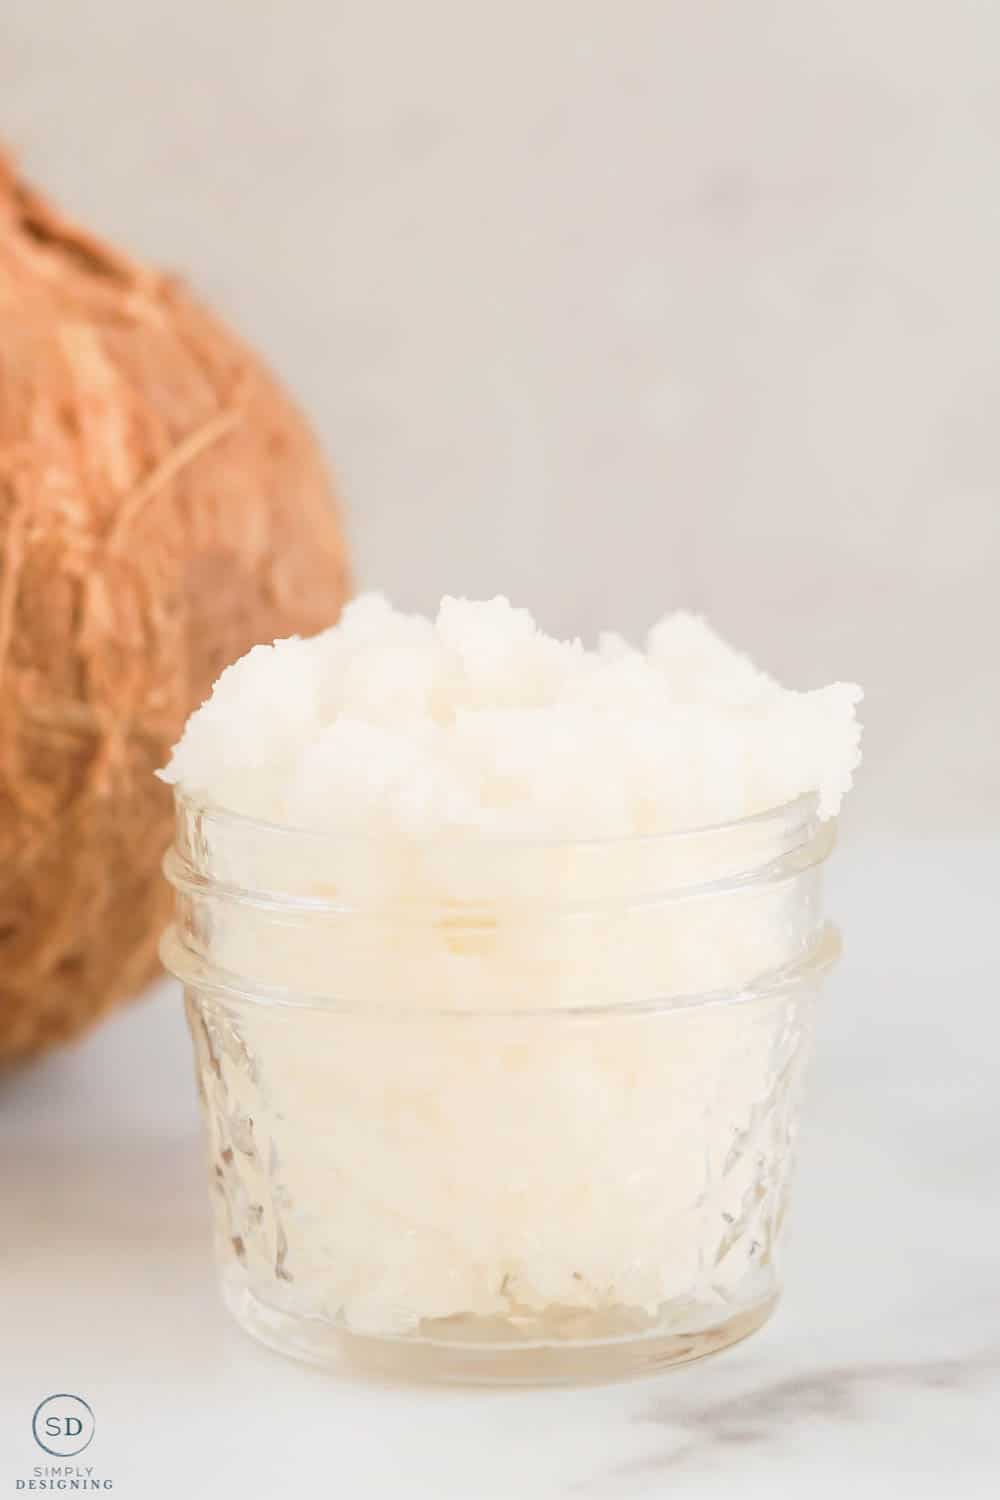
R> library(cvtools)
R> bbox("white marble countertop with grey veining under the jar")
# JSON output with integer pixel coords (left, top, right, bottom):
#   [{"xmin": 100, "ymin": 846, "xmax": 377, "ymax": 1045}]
[{"xmin": 0, "ymin": 839, "xmax": 1000, "ymax": 1500}]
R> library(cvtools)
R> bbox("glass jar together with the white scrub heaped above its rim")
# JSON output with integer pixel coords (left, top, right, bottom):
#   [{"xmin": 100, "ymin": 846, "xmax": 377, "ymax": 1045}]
[{"xmin": 163, "ymin": 596, "xmax": 861, "ymax": 1380}]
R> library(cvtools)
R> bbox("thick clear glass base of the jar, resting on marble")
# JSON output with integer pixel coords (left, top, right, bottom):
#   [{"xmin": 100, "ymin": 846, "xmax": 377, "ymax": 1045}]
[{"xmin": 222, "ymin": 1277, "xmax": 778, "ymax": 1386}]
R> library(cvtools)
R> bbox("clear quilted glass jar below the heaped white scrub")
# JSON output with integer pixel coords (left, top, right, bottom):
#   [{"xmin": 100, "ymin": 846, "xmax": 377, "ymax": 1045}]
[{"xmin": 163, "ymin": 795, "xmax": 837, "ymax": 1382}]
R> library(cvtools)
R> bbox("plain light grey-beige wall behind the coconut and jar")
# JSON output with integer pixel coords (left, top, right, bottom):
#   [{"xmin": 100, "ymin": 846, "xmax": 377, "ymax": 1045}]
[{"xmin": 0, "ymin": 0, "xmax": 1000, "ymax": 831}]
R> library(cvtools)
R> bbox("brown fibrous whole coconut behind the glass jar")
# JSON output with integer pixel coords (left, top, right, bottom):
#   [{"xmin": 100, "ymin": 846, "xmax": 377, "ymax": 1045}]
[{"xmin": 0, "ymin": 161, "xmax": 348, "ymax": 1061}]
